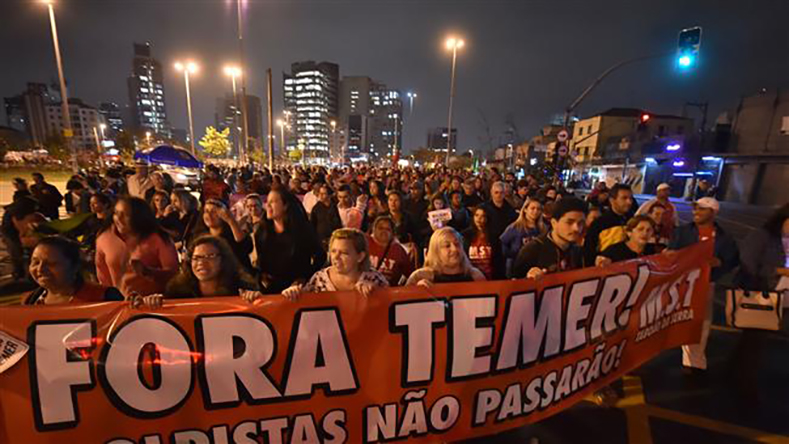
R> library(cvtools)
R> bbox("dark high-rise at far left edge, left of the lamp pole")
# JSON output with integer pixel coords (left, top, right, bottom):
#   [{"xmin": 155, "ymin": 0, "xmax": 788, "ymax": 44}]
[{"xmin": 3, "ymin": 82, "xmax": 60, "ymax": 146}]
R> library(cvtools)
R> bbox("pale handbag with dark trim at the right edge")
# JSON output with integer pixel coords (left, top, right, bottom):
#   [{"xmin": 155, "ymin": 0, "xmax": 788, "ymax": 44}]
[{"xmin": 726, "ymin": 288, "xmax": 784, "ymax": 331}]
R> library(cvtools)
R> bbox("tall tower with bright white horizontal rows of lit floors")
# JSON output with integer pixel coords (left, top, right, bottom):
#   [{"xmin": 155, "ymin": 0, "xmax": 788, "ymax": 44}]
[{"xmin": 284, "ymin": 61, "xmax": 340, "ymax": 163}]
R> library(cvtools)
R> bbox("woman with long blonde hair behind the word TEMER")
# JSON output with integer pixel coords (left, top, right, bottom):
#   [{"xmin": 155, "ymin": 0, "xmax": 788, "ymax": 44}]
[{"xmin": 406, "ymin": 227, "xmax": 485, "ymax": 286}]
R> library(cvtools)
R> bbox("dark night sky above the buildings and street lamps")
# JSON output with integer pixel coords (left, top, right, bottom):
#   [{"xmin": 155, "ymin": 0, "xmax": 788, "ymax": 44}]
[{"xmin": 0, "ymin": 0, "xmax": 789, "ymax": 150}]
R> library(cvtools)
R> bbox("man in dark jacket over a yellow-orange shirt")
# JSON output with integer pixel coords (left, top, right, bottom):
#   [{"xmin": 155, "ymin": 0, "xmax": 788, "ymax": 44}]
[{"xmin": 584, "ymin": 183, "xmax": 633, "ymax": 266}]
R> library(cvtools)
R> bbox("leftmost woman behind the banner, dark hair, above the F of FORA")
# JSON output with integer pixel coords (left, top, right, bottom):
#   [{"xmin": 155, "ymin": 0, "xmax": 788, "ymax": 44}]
[{"xmin": 24, "ymin": 236, "xmax": 123, "ymax": 305}]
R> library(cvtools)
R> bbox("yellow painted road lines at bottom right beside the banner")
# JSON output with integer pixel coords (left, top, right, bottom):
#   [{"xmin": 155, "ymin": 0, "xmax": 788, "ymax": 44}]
[{"xmin": 616, "ymin": 375, "xmax": 789, "ymax": 444}]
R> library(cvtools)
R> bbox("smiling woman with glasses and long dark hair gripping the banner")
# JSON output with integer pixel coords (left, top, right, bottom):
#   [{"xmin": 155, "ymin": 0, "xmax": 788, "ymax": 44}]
[{"xmin": 132, "ymin": 235, "xmax": 261, "ymax": 308}]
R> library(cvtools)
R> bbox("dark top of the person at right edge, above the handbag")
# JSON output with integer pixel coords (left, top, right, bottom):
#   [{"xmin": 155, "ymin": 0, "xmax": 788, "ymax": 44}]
[{"xmin": 737, "ymin": 229, "xmax": 787, "ymax": 291}]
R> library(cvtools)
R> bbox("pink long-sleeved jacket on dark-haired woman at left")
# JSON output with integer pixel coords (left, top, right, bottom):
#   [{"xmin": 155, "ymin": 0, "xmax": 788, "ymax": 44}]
[{"xmin": 96, "ymin": 227, "xmax": 178, "ymax": 297}]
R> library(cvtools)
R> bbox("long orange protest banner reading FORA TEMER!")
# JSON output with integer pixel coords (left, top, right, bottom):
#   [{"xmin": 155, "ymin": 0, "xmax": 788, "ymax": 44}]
[{"xmin": 0, "ymin": 243, "xmax": 712, "ymax": 444}]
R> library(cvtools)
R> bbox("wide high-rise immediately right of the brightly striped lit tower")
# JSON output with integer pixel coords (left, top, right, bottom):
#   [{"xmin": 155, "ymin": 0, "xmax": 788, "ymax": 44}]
[{"xmin": 340, "ymin": 76, "xmax": 403, "ymax": 161}]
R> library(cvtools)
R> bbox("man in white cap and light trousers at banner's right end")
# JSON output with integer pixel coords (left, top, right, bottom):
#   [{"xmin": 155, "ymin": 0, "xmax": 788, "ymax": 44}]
[{"xmin": 666, "ymin": 197, "xmax": 739, "ymax": 378}]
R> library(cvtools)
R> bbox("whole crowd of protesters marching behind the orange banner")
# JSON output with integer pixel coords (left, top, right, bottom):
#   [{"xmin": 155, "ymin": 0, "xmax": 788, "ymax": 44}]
[{"xmin": 2, "ymin": 163, "xmax": 789, "ymax": 406}]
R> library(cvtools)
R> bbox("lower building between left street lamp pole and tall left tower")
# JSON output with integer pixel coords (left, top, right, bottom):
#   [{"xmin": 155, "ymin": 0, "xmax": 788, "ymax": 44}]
[{"xmin": 45, "ymin": 98, "xmax": 106, "ymax": 149}]
